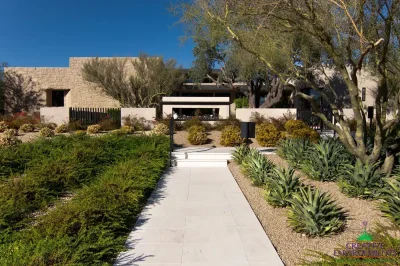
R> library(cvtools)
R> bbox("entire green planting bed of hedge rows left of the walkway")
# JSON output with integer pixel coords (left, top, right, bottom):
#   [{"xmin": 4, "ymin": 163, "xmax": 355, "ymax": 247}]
[{"xmin": 0, "ymin": 135, "xmax": 169, "ymax": 265}]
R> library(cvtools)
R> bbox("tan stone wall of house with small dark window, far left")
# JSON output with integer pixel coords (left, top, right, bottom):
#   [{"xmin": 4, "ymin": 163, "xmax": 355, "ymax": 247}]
[{"xmin": 4, "ymin": 57, "xmax": 120, "ymax": 107}]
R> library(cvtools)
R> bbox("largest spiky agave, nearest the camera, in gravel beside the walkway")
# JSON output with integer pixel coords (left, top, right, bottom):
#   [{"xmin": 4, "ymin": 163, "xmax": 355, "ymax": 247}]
[{"xmin": 288, "ymin": 187, "xmax": 346, "ymax": 236}]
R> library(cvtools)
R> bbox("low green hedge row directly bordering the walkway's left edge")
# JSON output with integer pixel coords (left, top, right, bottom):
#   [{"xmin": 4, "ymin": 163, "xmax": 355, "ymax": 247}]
[{"xmin": 0, "ymin": 137, "xmax": 168, "ymax": 265}]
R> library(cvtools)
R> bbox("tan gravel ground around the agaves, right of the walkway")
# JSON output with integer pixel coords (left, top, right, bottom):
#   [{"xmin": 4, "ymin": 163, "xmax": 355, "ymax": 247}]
[{"xmin": 228, "ymin": 155, "xmax": 389, "ymax": 265}]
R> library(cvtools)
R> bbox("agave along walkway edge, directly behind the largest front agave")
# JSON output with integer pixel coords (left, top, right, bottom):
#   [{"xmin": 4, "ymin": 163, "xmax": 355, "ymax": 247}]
[{"xmin": 265, "ymin": 168, "xmax": 301, "ymax": 207}]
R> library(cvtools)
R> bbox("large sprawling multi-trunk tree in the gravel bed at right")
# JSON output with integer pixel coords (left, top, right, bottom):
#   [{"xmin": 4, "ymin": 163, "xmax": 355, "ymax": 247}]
[{"xmin": 177, "ymin": 0, "xmax": 400, "ymax": 173}]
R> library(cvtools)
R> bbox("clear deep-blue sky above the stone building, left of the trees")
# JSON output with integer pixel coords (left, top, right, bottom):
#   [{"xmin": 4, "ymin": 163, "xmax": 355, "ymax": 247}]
[{"xmin": 0, "ymin": 0, "xmax": 193, "ymax": 67}]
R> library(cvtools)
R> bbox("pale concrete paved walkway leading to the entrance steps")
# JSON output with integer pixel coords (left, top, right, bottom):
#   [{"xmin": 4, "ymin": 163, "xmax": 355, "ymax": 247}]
[{"xmin": 115, "ymin": 167, "xmax": 283, "ymax": 266}]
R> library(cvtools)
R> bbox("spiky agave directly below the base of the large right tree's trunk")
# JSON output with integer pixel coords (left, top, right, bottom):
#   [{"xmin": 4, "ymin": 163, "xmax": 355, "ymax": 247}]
[{"xmin": 338, "ymin": 159, "xmax": 384, "ymax": 198}]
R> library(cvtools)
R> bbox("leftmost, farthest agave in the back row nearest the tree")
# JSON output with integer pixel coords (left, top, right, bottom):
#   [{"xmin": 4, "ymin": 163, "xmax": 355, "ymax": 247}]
[{"xmin": 277, "ymin": 139, "xmax": 311, "ymax": 169}]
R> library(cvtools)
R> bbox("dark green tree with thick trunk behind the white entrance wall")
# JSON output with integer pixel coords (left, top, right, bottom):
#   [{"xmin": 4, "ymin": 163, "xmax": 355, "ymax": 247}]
[{"xmin": 186, "ymin": 19, "xmax": 292, "ymax": 108}]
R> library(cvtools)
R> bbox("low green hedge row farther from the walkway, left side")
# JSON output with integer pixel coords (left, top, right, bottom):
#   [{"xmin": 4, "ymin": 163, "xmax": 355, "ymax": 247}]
[{"xmin": 0, "ymin": 136, "xmax": 168, "ymax": 239}]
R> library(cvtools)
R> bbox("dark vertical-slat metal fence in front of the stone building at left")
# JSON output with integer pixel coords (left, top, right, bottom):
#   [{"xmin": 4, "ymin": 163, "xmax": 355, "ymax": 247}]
[{"xmin": 69, "ymin": 107, "xmax": 121, "ymax": 126}]
